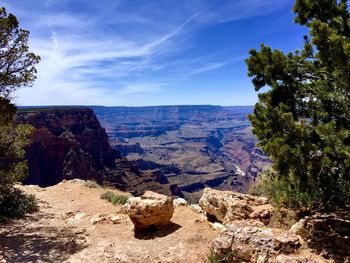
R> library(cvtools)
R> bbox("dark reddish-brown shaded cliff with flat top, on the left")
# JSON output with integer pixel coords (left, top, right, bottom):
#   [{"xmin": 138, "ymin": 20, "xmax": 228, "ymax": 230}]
[{"xmin": 15, "ymin": 108, "xmax": 119, "ymax": 186}]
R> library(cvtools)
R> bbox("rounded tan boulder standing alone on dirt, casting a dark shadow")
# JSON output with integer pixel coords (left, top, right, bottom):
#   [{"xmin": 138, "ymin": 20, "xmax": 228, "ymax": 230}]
[{"xmin": 123, "ymin": 191, "xmax": 174, "ymax": 229}]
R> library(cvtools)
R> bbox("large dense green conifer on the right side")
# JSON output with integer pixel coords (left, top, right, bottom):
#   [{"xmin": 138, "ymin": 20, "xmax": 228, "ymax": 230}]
[{"xmin": 246, "ymin": 0, "xmax": 350, "ymax": 210}]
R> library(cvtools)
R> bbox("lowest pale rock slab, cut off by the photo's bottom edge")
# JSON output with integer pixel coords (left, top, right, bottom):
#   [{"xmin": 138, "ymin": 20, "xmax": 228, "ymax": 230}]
[{"xmin": 212, "ymin": 221, "xmax": 327, "ymax": 263}]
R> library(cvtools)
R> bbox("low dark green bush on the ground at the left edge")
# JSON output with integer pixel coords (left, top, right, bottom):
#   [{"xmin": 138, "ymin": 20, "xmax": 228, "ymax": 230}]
[{"xmin": 0, "ymin": 187, "xmax": 38, "ymax": 223}]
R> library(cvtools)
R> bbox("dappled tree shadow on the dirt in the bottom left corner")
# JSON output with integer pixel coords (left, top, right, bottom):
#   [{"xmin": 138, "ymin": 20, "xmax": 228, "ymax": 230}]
[{"xmin": 0, "ymin": 215, "xmax": 87, "ymax": 262}]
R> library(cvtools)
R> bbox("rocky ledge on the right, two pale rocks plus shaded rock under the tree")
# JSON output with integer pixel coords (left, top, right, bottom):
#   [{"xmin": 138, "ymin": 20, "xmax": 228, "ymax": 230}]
[{"xmin": 199, "ymin": 188, "xmax": 350, "ymax": 263}]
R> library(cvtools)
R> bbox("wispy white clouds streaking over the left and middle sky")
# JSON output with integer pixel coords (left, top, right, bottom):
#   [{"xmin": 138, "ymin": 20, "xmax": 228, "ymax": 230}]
[{"xmin": 4, "ymin": 0, "xmax": 290, "ymax": 104}]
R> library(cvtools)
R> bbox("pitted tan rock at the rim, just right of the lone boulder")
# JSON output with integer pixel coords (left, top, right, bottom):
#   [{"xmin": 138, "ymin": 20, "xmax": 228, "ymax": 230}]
[{"xmin": 199, "ymin": 188, "xmax": 273, "ymax": 225}]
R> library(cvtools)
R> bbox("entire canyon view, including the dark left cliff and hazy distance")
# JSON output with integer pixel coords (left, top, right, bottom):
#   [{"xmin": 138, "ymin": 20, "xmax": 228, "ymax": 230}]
[{"xmin": 15, "ymin": 105, "xmax": 271, "ymax": 203}]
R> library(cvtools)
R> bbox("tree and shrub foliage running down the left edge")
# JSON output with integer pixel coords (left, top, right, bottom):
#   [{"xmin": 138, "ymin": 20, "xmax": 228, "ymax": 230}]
[{"xmin": 0, "ymin": 8, "xmax": 40, "ymax": 221}]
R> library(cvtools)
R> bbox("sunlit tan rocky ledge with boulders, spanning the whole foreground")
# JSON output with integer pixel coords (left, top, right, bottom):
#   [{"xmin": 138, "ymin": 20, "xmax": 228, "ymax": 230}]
[{"xmin": 0, "ymin": 182, "xmax": 350, "ymax": 263}]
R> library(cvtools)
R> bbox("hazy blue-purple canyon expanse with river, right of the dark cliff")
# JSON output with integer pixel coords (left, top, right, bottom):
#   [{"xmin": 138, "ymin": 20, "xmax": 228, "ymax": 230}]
[{"xmin": 92, "ymin": 105, "xmax": 271, "ymax": 202}]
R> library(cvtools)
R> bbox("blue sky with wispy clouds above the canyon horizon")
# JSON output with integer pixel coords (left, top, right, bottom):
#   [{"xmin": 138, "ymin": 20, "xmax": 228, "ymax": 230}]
[{"xmin": 1, "ymin": 0, "xmax": 306, "ymax": 106}]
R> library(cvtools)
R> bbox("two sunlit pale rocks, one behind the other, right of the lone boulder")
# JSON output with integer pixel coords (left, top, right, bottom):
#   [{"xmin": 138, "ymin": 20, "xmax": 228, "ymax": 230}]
[{"xmin": 199, "ymin": 188, "xmax": 330, "ymax": 263}]
